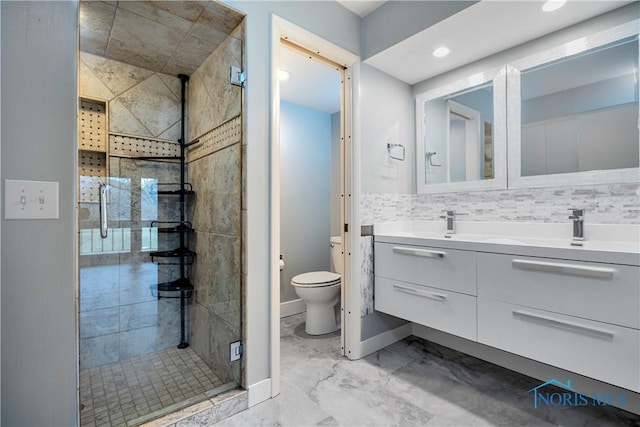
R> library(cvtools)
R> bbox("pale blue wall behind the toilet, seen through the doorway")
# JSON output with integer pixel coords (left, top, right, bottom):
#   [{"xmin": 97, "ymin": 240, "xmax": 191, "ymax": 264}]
[{"xmin": 280, "ymin": 102, "xmax": 331, "ymax": 302}]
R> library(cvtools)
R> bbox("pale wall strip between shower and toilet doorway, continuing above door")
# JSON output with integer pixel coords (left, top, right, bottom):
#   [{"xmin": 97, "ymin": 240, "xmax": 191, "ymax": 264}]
[{"xmin": 221, "ymin": 0, "xmax": 360, "ymax": 398}]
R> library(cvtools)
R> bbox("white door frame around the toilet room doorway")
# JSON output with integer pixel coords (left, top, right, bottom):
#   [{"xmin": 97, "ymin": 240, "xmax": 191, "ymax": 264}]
[{"xmin": 269, "ymin": 15, "xmax": 360, "ymax": 397}]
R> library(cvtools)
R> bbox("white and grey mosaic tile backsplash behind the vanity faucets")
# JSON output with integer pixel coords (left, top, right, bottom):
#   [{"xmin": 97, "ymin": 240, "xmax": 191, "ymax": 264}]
[{"xmin": 360, "ymin": 184, "xmax": 640, "ymax": 317}]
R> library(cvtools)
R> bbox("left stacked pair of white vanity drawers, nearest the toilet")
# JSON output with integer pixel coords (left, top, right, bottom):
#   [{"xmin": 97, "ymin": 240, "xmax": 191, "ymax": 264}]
[{"xmin": 374, "ymin": 243, "xmax": 476, "ymax": 341}]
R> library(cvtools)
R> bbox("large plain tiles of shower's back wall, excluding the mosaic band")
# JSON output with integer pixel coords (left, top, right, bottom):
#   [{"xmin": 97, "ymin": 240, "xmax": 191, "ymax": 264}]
[{"xmin": 80, "ymin": 53, "xmax": 180, "ymax": 369}]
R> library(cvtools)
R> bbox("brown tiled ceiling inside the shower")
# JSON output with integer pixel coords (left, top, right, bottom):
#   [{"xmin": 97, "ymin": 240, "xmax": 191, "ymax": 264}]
[{"xmin": 80, "ymin": 0, "xmax": 243, "ymax": 75}]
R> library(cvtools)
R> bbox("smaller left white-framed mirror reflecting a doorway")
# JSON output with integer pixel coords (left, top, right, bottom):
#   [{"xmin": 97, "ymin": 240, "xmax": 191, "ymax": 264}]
[{"xmin": 416, "ymin": 70, "xmax": 506, "ymax": 193}]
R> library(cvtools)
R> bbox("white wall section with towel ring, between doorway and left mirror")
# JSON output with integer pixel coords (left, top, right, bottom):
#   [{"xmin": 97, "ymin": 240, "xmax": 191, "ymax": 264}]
[{"xmin": 360, "ymin": 64, "xmax": 415, "ymax": 193}]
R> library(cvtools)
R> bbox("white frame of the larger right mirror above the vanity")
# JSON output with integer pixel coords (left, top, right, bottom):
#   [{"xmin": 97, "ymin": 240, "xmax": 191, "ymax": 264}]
[{"xmin": 507, "ymin": 19, "xmax": 640, "ymax": 188}]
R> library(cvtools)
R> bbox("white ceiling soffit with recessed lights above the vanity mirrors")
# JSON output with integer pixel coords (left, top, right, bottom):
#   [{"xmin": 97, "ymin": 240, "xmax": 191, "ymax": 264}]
[{"xmin": 365, "ymin": 0, "xmax": 632, "ymax": 85}]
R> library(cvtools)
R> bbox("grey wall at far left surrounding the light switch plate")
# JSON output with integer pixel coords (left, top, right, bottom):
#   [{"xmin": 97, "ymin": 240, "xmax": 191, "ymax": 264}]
[{"xmin": 0, "ymin": 2, "xmax": 77, "ymax": 426}]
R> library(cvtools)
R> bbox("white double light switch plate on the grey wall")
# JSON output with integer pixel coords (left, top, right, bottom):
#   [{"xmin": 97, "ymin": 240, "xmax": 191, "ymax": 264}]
[{"xmin": 4, "ymin": 179, "xmax": 59, "ymax": 219}]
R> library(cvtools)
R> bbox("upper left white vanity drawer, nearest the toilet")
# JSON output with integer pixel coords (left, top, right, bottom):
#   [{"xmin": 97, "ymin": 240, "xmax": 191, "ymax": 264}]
[{"xmin": 374, "ymin": 243, "xmax": 476, "ymax": 295}]
